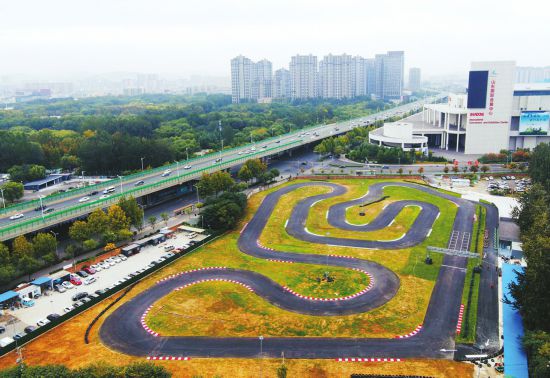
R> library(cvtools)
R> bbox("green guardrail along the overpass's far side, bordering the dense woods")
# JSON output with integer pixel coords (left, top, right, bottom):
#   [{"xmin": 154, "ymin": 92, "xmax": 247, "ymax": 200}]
[{"xmin": 0, "ymin": 99, "xmax": 440, "ymax": 215}]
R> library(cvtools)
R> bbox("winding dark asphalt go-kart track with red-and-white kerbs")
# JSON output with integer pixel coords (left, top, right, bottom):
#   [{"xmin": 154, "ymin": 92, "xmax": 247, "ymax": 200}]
[{"xmin": 100, "ymin": 182, "xmax": 484, "ymax": 358}]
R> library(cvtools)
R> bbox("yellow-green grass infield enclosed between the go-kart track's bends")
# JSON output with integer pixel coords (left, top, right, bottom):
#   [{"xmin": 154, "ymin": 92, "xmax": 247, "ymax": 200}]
[{"xmin": 147, "ymin": 179, "xmax": 456, "ymax": 337}]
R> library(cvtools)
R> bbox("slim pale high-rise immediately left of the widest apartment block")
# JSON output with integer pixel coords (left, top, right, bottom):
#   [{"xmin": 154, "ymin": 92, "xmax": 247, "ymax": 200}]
[{"xmin": 290, "ymin": 54, "xmax": 317, "ymax": 99}]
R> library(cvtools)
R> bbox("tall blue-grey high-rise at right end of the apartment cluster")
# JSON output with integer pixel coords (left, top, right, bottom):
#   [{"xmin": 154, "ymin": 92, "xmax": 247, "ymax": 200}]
[{"xmin": 374, "ymin": 51, "xmax": 405, "ymax": 100}]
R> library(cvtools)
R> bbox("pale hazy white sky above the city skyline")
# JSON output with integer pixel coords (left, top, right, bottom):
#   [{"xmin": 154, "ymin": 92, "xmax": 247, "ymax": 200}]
[{"xmin": 0, "ymin": 0, "xmax": 550, "ymax": 76}]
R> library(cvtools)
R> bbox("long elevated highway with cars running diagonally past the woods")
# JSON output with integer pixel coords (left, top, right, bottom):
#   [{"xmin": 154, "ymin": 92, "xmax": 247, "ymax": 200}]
[{"xmin": 0, "ymin": 95, "xmax": 446, "ymax": 241}]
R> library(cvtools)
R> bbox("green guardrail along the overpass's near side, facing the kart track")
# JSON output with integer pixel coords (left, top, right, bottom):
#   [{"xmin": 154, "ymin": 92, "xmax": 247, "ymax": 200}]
[{"xmin": 0, "ymin": 141, "xmax": 298, "ymax": 238}]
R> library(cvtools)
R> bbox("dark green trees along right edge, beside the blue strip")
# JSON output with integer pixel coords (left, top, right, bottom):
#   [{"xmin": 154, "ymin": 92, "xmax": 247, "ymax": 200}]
[{"xmin": 508, "ymin": 143, "xmax": 550, "ymax": 377}]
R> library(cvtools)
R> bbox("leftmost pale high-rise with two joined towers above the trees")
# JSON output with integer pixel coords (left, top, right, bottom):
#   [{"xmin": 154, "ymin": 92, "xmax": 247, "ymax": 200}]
[{"xmin": 231, "ymin": 55, "xmax": 272, "ymax": 104}]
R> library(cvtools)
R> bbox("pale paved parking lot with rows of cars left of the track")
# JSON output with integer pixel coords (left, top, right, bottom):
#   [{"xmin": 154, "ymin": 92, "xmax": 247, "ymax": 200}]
[{"xmin": 0, "ymin": 232, "xmax": 207, "ymax": 338}]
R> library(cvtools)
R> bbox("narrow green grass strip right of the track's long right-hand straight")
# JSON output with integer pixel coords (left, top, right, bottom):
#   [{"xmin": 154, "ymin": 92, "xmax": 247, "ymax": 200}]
[{"xmin": 456, "ymin": 205, "xmax": 486, "ymax": 343}]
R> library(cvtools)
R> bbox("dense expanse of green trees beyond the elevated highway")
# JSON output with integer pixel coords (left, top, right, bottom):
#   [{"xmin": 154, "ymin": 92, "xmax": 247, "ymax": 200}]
[{"xmin": 0, "ymin": 95, "xmax": 386, "ymax": 174}]
